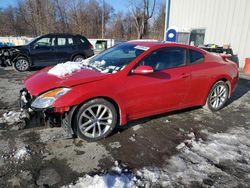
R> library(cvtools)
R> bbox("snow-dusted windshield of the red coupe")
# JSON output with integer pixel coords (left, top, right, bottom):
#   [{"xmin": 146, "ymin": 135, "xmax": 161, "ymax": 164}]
[{"xmin": 87, "ymin": 43, "xmax": 149, "ymax": 73}]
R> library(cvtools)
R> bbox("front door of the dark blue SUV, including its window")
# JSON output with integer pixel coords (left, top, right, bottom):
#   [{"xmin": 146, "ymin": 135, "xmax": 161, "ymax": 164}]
[{"xmin": 30, "ymin": 36, "xmax": 56, "ymax": 67}]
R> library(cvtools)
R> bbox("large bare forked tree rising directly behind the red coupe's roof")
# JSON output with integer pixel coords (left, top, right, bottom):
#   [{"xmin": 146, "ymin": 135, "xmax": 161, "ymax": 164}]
[{"xmin": 131, "ymin": 0, "xmax": 155, "ymax": 39}]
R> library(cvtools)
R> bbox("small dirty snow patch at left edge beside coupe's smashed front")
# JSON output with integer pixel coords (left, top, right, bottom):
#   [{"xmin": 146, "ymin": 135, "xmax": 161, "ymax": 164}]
[{"xmin": 0, "ymin": 111, "xmax": 28, "ymax": 125}]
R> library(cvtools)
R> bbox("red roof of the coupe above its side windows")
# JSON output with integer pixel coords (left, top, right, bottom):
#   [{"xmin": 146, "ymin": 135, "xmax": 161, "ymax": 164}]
[{"xmin": 128, "ymin": 40, "xmax": 207, "ymax": 54}]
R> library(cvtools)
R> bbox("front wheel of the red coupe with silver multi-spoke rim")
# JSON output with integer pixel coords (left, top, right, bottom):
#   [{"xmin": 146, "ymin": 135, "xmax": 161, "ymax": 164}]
[{"xmin": 73, "ymin": 98, "xmax": 117, "ymax": 142}]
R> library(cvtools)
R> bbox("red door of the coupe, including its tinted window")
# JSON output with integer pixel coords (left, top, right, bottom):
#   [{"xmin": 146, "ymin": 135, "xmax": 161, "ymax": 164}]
[{"xmin": 120, "ymin": 47, "xmax": 190, "ymax": 119}]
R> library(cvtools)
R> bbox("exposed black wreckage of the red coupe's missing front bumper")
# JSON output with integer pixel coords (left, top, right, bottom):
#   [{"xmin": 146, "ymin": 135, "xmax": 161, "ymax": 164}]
[{"xmin": 19, "ymin": 89, "xmax": 76, "ymax": 136}]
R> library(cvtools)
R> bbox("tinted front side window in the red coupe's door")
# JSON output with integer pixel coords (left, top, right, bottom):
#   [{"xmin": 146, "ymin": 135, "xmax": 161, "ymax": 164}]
[{"xmin": 139, "ymin": 47, "xmax": 186, "ymax": 71}]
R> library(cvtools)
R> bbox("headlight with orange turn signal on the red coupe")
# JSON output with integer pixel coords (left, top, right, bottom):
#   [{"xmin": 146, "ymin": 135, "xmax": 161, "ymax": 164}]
[{"xmin": 31, "ymin": 88, "xmax": 71, "ymax": 108}]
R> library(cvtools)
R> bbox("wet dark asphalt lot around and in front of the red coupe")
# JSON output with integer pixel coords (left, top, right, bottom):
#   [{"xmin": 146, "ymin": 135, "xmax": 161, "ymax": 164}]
[{"xmin": 0, "ymin": 68, "xmax": 250, "ymax": 187}]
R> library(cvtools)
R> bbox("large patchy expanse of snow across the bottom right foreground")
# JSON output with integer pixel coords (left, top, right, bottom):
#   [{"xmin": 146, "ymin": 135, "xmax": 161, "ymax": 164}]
[{"xmin": 65, "ymin": 127, "xmax": 250, "ymax": 188}]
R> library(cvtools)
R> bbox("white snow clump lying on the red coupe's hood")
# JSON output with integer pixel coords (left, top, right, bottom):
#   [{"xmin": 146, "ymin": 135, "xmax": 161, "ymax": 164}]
[{"xmin": 48, "ymin": 61, "xmax": 87, "ymax": 77}]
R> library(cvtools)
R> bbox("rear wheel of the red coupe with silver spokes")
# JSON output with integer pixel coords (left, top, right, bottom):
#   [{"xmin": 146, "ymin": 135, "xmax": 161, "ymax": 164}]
[{"xmin": 204, "ymin": 81, "xmax": 229, "ymax": 111}]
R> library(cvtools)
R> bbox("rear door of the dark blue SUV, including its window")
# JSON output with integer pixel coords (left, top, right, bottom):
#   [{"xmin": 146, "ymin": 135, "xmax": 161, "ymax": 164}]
[{"xmin": 56, "ymin": 36, "xmax": 75, "ymax": 63}]
